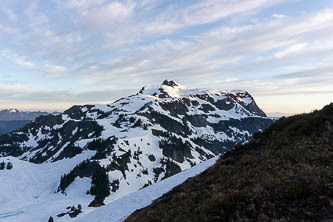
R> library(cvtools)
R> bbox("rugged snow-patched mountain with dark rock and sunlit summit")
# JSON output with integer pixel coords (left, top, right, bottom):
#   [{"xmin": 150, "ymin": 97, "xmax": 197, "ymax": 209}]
[{"xmin": 0, "ymin": 80, "xmax": 273, "ymax": 220}]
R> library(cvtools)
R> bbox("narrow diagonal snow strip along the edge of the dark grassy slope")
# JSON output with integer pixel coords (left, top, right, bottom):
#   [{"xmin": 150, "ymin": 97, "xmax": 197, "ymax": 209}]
[{"xmin": 77, "ymin": 157, "xmax": 218, "ymax": 222}]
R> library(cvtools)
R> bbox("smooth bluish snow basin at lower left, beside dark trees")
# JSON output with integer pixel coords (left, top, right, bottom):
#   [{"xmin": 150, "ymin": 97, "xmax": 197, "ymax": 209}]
[{"xmin": 0, "ymin": 152, "xmax": 94, "ymax": 222}]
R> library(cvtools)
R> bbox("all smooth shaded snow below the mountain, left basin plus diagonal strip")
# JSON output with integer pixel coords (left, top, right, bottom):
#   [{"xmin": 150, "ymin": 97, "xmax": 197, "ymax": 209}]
[{"xmin": 0, "ymin": 153, "xmax": 218, "ymax": 222}]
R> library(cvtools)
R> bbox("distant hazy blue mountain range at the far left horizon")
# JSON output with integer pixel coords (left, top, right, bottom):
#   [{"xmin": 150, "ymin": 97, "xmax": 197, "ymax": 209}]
[{"xmin": 0, "ymin": 109, "xmax": 49, "ymax": 135}]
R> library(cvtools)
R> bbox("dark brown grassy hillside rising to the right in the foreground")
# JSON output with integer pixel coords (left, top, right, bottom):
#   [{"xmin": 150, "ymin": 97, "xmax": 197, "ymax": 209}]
[{"xmin": 126, "ymin": 104, "xmax": 333, "ymax": 222}]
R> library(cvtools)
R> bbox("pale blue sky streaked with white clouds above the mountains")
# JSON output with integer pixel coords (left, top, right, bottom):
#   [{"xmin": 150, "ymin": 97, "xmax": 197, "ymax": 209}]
[{"xmin": 0, "ymin": 0, "xmax": 333, "ymax": 113}]
